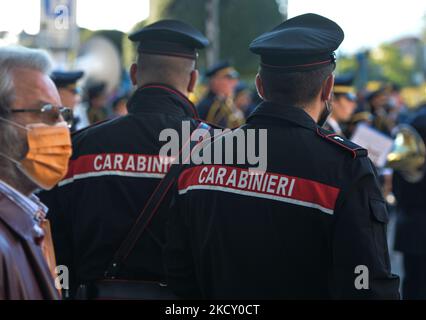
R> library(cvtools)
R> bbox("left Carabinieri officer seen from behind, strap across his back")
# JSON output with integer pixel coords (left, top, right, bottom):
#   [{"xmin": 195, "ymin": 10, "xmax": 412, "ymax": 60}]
[{"xmin": 39, "ymin": 20, "xmax": 208, "ymax": 295}]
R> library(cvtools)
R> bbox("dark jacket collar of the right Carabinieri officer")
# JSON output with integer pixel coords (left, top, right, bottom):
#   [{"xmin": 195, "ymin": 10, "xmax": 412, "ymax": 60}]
[{"xmin": 247, "ymin": 101, "xmax": 318, "ymax": 131}]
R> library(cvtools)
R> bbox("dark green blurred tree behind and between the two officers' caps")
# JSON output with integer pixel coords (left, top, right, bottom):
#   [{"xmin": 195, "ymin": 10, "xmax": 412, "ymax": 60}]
[{"xmin": 130, "ymin": 0, "xmax": 283, "ymax": 77}]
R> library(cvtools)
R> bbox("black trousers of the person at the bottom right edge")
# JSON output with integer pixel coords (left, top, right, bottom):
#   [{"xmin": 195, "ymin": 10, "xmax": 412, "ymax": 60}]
[{"xmin": 402, "ymin": 254, "xmax": 426, "ymax": 300}]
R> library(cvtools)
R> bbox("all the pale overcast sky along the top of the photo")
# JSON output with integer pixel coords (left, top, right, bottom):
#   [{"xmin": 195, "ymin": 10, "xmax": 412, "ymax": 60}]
[{"xmin": 0, "ymin": 0, "xmax": 426, "ymax": 52}]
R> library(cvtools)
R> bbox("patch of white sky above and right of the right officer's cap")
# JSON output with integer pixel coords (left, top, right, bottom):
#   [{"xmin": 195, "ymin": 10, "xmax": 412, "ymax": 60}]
[{"xmin": 288, "ymin": 0, "xmax": 426, "ymax": 52}]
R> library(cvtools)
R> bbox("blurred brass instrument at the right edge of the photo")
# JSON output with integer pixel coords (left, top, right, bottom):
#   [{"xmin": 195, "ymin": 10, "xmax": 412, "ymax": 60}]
[{"xmin": 386, "ymin": 124, "xmax": 426, "ymax": 183}]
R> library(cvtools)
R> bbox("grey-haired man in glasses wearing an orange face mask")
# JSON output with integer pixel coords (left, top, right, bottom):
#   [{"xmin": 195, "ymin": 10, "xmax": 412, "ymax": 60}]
[{"xmin": 0, "ymin": 47, "xmax": 71, "ymax": 300}]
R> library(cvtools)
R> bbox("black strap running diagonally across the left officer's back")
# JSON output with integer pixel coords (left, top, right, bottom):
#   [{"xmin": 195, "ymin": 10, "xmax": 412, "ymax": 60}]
[{"xmin": 105, "ymin": 122, "xmax": 211, "ymax": 279}]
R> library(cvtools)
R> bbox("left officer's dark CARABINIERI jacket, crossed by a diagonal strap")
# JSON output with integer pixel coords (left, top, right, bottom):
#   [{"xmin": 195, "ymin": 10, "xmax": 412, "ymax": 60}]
[{"xmin": 40, "ymin": 84, "xmax": 203, "ymax": 289}]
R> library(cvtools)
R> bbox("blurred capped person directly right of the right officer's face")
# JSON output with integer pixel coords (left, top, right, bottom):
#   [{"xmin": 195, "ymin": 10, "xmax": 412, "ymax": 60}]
[{"xmin": 324, "ymin": 76, "xmax": 356, "ymax": 136}]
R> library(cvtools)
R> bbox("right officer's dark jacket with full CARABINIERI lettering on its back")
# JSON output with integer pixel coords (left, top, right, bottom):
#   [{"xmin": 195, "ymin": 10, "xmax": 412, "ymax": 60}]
[{"xmin": 165, "ymin": 102, "xmax": 399, "ymax": 299}]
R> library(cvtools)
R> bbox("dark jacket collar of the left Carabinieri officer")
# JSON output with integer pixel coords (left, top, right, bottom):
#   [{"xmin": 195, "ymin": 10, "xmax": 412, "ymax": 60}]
[{"xmin": 127, "ymin": 83, "xmax": 198, "ymax": 119}]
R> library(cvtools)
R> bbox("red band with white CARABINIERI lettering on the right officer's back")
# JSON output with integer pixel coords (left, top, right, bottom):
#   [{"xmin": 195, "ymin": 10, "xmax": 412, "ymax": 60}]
[{"xmin": 178, "ymin": 165, "xmax": 340, "ymax": 214}]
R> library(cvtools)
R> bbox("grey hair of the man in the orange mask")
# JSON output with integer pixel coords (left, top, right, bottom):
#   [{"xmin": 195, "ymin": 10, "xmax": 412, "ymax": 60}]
[{"xmin": 0, "ymin": 46, "xmax": 52, "ymax": 117}]
